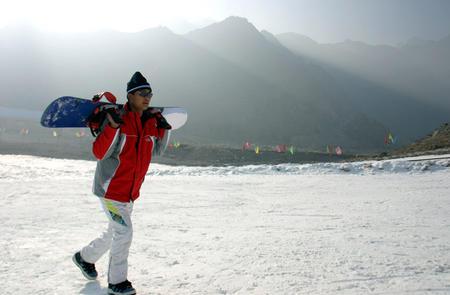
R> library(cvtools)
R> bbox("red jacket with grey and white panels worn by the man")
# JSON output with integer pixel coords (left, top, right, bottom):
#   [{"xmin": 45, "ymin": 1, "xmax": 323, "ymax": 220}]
[{"xmin": 92, "ymin": 105, "xmax": 170, "ymax": 202}]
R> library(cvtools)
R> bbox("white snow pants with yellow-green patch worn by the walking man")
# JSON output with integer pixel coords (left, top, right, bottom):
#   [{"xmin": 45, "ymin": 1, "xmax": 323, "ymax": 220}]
[{"xmin": 81, "ymin": 198, "xmax": 133, "ymax": 284}]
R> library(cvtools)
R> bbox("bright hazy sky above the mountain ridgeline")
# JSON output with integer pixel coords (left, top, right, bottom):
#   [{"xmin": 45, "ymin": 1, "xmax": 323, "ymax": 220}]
[{"xmin": 0, "ymin": 0, "xmax": 450, "ymax": 44}]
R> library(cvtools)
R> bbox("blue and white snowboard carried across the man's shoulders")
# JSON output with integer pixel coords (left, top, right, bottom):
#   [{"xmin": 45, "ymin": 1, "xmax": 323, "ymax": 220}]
[{"xmin": 41, "ymin": 96, "xmax": 187, "ymax": 130}]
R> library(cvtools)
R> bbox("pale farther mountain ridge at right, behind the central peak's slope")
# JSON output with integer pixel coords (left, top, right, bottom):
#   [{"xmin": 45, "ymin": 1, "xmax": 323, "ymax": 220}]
[{"xmin": 276, "ymin": 33, "xmax": 450, "ymax": 110}]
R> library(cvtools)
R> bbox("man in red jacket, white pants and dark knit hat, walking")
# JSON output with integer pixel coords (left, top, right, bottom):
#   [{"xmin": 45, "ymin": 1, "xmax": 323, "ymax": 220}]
[{"xmin": 72, "ymin": 72, "xmax": 170, "ymax": 295}]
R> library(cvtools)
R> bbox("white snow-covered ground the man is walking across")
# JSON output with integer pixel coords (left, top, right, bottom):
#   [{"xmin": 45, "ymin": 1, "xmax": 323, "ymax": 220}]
[{"xmin": 0, "ymin": 155, "xmax": 450, "ymax": 295}]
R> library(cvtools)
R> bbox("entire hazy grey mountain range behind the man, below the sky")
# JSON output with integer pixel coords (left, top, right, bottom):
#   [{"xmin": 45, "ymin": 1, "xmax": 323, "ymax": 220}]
[{"xmin": 0, "ymin": 17, "xmax": 450, "ymax": 151}]
